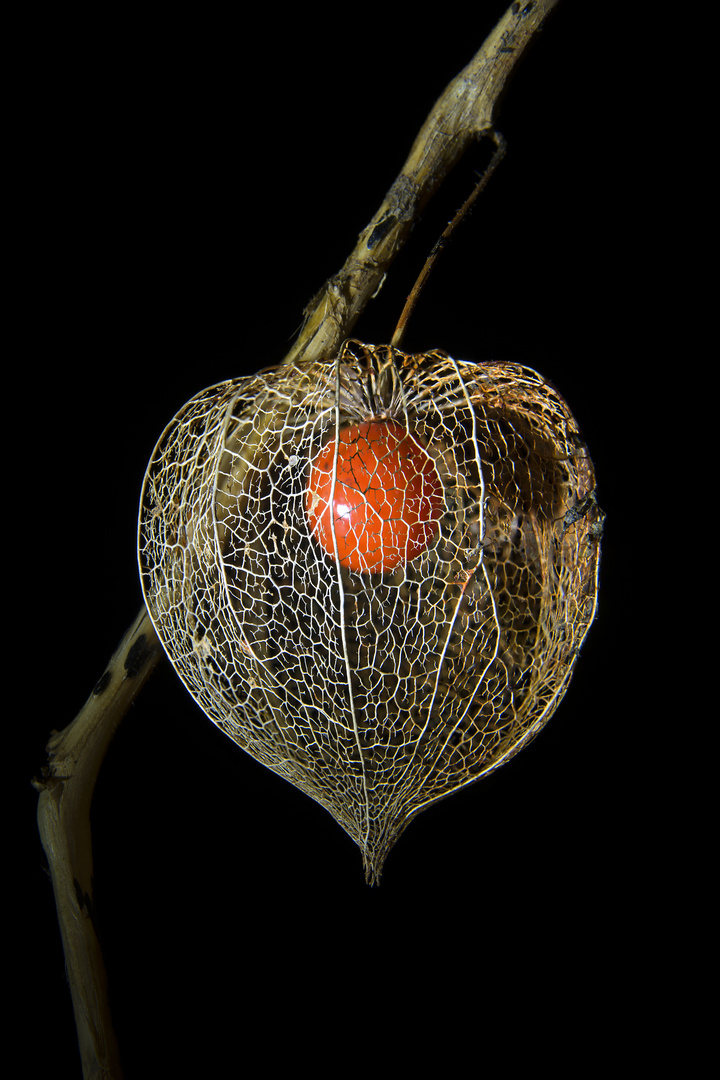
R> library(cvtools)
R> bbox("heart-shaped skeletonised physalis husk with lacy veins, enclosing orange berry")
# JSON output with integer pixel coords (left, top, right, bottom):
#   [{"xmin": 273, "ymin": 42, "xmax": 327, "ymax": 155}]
[{"xmin": 139, "ymin": 341, "xmax": 603, "ymax": 881}]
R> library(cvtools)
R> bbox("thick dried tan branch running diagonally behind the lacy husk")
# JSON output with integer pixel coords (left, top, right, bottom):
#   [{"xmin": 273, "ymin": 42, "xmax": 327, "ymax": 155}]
[{"xmin": 35, "ymin": 0, "xmax": 558, "ymax": 1080}]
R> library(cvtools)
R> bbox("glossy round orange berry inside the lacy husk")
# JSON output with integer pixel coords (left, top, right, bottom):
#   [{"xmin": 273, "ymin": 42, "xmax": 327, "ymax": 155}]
[{"xmin": 305, "ymin": 420, "xmax": 443, "ymax": 573}]
